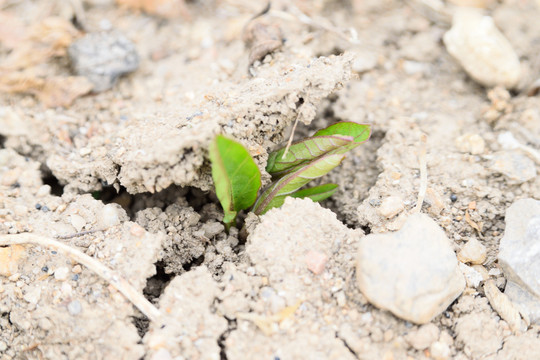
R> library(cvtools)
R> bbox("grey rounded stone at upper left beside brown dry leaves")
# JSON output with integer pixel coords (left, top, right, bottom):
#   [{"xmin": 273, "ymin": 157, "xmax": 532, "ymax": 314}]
[{"xmin": 68, "ymin": 31, "xmax": 139, "ymax": 92}]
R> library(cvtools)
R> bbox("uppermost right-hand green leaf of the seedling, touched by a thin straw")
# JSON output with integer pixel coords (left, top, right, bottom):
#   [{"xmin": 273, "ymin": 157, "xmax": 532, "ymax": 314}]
[{"xmin": 266, "ymin": 121, "xmax": 371, "ymax": 178}]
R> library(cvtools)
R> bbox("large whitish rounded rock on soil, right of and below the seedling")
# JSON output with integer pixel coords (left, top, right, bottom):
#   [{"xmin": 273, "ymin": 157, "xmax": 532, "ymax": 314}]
[{"xmin": 357, "ymin": 214, "xmax": 465, "ymax": 324}]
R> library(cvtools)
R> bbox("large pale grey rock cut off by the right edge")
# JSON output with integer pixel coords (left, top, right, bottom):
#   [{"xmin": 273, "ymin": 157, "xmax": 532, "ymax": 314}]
[{"xmin": 499, "ymin": 199, "xmax": 540, "ymax": 323}]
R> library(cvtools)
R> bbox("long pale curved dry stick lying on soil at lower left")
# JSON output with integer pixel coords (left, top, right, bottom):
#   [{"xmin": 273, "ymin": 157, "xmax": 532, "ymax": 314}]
[{"xmin": 0, "ymin": 233, "xmax": 162, "ymax": 321}]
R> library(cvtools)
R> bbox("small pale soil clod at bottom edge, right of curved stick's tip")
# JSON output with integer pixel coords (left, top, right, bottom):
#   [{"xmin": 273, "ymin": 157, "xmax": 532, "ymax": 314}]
[{"xmin": 144, "ymin": 266, "xmax": 227, "ymax": 359}]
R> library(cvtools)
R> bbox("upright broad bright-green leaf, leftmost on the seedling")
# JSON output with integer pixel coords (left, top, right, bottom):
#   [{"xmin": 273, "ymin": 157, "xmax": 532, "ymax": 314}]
[{"xmin": 210, "ymin": 135, "xmax": 261, "ymax": 229}]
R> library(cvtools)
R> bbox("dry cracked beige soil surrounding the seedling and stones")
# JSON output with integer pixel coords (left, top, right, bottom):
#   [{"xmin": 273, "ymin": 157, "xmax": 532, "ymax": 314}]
[{"xmin": 0, "ymin": 0, "xmax": 540, "ymax": 360}]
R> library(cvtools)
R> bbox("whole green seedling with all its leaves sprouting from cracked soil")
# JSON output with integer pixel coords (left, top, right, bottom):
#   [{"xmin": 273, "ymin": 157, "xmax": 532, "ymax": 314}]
[{"xmin": 210, "ymin": 122, "xmax": 371, "ymax": 228}]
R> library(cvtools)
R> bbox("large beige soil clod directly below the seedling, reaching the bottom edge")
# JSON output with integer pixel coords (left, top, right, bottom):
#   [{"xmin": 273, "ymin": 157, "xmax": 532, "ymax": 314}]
[{"xmin": 218, "ymin": 198, "xmax": 361, "ymax": 359}]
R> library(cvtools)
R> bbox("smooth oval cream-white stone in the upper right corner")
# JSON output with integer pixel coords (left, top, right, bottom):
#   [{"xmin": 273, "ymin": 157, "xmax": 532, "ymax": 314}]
[{"xmin": 443, "ymin": 7, "xmax": 521, "ymax": 88}]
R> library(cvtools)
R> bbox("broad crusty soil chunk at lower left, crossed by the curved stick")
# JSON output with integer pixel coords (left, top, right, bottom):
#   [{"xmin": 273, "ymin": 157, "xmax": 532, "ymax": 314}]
[{"xmin": 0, "ymin": 150, "xmax": 163, "ymax": 359}]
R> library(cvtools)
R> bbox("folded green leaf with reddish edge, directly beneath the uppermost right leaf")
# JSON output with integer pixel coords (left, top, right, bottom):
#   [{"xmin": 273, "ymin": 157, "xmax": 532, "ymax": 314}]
[{"xmin": 253, "ymin": 154, "xmax": 345, "ymax": 215}]
